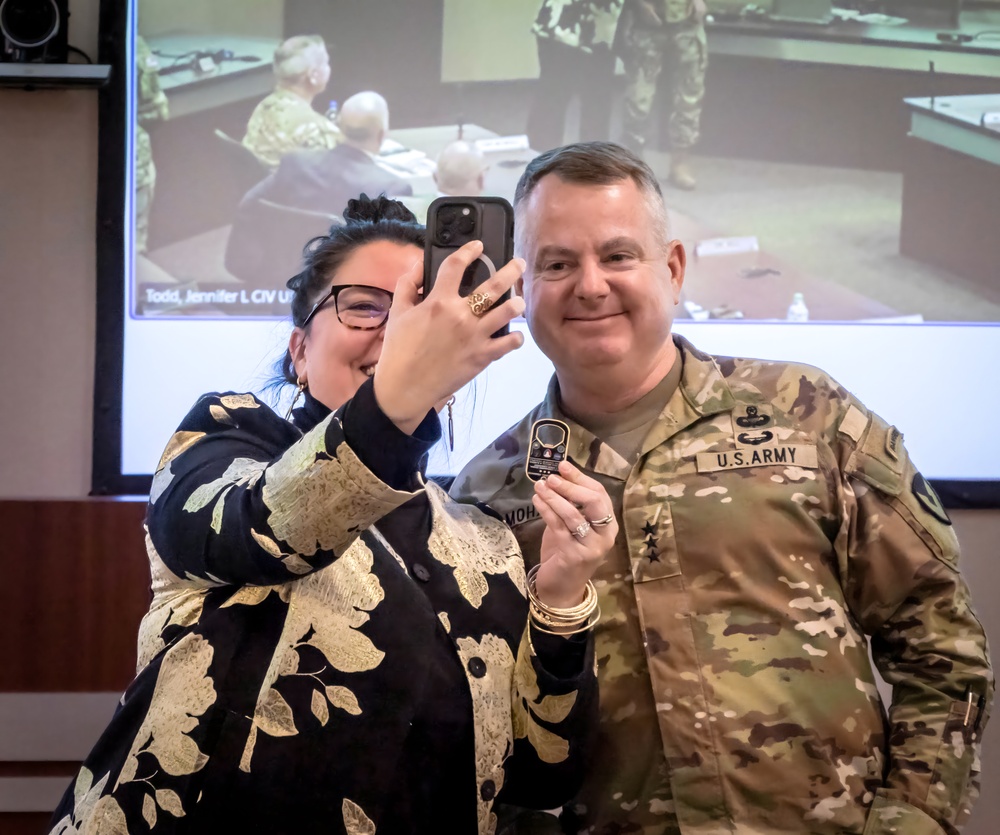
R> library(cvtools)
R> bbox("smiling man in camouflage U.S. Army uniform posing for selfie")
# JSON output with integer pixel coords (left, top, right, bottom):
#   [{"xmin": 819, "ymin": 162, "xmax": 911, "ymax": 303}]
[{"xmin": 452, "ymin": 143, "xmax": 993, "ymax": 835}]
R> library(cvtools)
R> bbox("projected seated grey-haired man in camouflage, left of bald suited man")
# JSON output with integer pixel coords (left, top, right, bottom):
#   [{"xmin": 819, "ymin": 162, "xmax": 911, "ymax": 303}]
[{"xmin": 243, "ymin": 35, "xmax": 341, "ymax": 170}]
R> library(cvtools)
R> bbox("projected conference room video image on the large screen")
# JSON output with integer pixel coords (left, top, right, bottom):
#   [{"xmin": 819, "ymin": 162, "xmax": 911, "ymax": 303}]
[{"xmin": 127, "ymin": 0, "xmax": 1000, "ymax": 324}]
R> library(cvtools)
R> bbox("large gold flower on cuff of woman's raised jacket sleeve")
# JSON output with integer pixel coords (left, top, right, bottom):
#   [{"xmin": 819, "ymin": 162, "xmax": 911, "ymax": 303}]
[{"xmin": 263, "ymin": 422, "xmax": 414, "ymax": 556}]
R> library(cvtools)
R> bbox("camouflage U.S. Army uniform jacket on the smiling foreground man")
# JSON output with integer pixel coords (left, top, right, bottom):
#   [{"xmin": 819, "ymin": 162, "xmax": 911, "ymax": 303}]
[{"xmin": 452, "ymin": 337, "xmax": 993, "ymax": 835}]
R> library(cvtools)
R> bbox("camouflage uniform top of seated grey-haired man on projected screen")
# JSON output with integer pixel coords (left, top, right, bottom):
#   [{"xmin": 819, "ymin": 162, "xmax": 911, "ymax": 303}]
[{"xmin": 243, "ymin": 88, "xmax": 341, "ymax": 169}]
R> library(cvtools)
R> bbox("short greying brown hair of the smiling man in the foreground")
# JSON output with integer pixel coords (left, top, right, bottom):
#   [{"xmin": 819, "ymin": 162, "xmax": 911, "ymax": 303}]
[{"xmin": 514, "ymin": 142, "xmax": 670, "ymax": 257}]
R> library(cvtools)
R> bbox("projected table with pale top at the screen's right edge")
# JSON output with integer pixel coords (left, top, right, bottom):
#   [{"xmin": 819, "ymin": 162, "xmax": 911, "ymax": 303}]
[{"xmin": 899, "ymin": 95, "xmax": 1000, "ymax": 298}]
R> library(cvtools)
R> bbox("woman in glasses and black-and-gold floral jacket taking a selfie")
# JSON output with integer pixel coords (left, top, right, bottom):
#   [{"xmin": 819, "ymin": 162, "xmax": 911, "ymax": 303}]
[{"xmin": 54, "ymin": 197, "xmax": 616, "ymax": 835}]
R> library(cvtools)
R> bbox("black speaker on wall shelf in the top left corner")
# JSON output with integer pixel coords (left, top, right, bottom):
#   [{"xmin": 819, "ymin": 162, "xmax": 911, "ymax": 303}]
[{"xmin": 0, "ymin": 0, "xmax": 69, "ymax": 64}]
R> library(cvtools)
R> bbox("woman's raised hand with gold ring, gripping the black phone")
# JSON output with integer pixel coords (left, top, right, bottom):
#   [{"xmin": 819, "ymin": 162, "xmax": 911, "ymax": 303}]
[{"xmin": 374, "ymin": 241, "xmax": 524, "ymax": 434}]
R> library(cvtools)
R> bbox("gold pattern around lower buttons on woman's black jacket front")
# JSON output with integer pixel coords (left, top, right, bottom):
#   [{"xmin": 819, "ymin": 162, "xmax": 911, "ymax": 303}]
[{"xmin": 456, "ymin": 632, "xmax": 514, "ymax": 835}]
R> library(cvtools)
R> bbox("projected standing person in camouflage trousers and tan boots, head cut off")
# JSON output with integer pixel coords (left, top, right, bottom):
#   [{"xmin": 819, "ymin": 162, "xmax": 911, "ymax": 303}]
[{"xmin": 615, "ymin": 0, "xmax": 708, "ymax": 190}]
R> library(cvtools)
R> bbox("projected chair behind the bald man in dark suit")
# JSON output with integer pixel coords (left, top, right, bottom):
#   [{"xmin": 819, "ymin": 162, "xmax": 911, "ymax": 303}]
[{"xmin": 225, "ymin": 197, "xmax": 343, "ymax": 290}]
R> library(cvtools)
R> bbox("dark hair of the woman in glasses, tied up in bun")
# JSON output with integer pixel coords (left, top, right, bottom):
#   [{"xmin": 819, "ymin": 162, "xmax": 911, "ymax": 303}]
[{"xmin": 268, "ymin": 194, "xmax": 424, "ymax": 388}]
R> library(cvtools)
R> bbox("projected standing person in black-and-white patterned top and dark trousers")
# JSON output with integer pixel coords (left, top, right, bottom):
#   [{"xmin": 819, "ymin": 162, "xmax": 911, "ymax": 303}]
[{"xmin": 528, "ymin": 0, "xmax": 622, "ymax": 151}]
